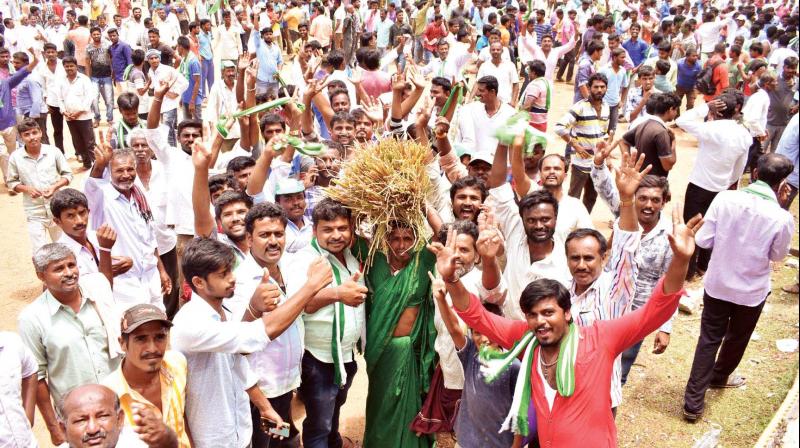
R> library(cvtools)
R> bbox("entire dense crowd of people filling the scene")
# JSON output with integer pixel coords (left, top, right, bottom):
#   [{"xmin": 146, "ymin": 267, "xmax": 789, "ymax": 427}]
[{"xmin": 0, "ymin": 0, "xmax": 800, "ymax": 448}]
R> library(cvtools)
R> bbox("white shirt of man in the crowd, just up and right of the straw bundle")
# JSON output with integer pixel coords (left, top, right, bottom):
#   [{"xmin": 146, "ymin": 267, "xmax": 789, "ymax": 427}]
[{"xmin": 458, "ymin": 101, "xmax": 516, "ymax": 154}]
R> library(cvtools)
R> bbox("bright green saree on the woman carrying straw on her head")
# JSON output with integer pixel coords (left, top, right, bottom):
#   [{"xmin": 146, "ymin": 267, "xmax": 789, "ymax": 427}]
[{"xmin": 364, "ymin": 245, "xmax": 436, "ymax": 448}]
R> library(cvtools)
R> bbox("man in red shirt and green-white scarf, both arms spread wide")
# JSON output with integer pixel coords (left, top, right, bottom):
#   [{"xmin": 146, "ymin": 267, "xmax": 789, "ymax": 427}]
[{"xmin": 429, "ymin": 150, "xmax": 702, "ymax": 447}]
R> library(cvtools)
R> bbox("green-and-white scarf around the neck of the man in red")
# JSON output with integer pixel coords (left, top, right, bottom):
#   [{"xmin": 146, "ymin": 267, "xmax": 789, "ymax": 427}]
[{"xmin": 479, "ymin": 322, "xmax": 580, "ymax": 436}]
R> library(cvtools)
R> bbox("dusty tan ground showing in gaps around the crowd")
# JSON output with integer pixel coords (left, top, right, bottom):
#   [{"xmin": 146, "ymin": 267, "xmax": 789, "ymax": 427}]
[{"xmin": 0, "ymin": 79, "xmax": 798, "ymax": 447}]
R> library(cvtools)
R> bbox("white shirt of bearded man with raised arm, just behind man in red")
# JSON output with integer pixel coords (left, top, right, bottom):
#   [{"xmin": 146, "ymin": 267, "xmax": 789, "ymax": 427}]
[{"xmin": 489, "ymin": 183, "xmax": 572, "ymax": 319}]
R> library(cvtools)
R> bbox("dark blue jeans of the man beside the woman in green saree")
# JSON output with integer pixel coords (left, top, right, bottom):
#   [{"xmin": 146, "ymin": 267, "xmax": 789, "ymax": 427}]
[{"xmin": 299, "ymin": 351, "xmax": 358, "ymax": 448}]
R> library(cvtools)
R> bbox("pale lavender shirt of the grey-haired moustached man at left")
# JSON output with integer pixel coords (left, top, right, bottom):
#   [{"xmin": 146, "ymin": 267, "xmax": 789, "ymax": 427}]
[{"xmin": 84, "ymin": 177, "xmax": 158, "ymax": 277}]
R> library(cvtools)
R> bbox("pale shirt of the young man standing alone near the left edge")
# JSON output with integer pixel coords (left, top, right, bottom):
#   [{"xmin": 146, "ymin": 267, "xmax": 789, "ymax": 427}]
[{"xmin": 6, "ymin": 144, "xmax": 72, "ymax": 220}]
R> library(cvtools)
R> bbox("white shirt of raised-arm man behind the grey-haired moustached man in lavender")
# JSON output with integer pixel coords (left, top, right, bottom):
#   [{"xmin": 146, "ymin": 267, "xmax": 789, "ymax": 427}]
[{"xmin": 145, "ymin": 125, "xmax": 194, "ymax": 235}]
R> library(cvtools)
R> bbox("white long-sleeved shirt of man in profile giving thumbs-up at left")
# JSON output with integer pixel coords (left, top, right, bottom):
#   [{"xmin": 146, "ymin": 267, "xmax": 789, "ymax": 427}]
[{"xmin": 170, "ymin": 294, "xmax": 270, "ymax": 448}]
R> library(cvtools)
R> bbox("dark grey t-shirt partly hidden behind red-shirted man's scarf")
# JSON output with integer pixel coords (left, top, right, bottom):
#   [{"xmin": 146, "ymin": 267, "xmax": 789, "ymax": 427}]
[{"xmin": 455, "ymin": 337, "xmax": 520, "ymax": 448}]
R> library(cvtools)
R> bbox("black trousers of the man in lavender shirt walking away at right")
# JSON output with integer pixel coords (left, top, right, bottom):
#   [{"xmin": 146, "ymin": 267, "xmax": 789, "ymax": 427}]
[{"xmin": 683, "ymin": 293, "xmax": 767, "ymax": 413}]
